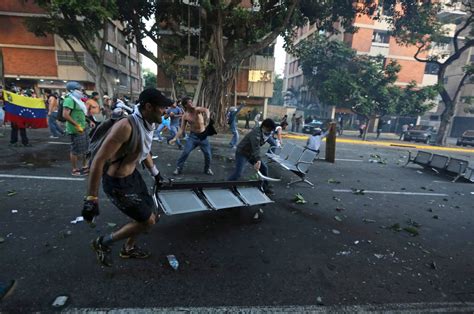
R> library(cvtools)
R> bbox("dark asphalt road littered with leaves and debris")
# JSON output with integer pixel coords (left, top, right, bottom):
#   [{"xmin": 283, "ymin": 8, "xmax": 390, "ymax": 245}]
[{"xmin": 0, "ymin": 131, "xmax": 474, "ymax": 312}]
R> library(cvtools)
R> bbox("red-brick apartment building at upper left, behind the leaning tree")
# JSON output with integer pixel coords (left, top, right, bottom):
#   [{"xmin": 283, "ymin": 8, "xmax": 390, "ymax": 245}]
[{"xmin": 0, "ymin": 0, "xmax": 142, "ymax": 98}]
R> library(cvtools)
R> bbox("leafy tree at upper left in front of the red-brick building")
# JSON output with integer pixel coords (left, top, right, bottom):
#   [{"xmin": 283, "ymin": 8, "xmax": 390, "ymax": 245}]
[{"xmin": 25, "ymin": 0, "xmax": 117, "ymax": 94}]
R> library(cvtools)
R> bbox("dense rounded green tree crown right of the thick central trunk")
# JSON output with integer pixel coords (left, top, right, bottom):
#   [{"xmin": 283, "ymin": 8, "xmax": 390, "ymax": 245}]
[{"xmin": 294, "ymin": 36, "xmax": 436, "ymax": 139}]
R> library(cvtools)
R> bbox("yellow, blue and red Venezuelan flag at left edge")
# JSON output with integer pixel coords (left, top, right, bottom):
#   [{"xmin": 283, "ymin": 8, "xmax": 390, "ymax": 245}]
[{"xmin": 3, "ymin": 91, "xmax": 48, "ymax": 129}]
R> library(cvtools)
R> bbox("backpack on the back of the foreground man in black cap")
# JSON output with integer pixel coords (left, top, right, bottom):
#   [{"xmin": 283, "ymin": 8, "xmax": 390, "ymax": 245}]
[{"xmin": 86, "ymin": 115, "xmax": 140, "ymax": 169}]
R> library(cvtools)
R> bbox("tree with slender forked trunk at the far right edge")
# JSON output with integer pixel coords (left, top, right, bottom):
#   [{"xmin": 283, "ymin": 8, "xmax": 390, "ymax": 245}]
[{"xmin": 381, "ymin": 0, "xmax": 474, "ymax": 145}]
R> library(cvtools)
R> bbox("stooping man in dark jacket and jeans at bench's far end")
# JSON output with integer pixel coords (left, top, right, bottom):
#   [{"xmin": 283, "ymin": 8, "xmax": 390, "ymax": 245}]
[{"xmin": 228, "ymin": 119, "xmax": 275, "ymax": 194}]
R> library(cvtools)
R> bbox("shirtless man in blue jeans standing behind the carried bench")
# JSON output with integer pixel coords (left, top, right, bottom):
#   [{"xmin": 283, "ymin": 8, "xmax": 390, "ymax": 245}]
[{"xmin": 170, "ymin": 97, "xmax": 214, "ymax": 176}]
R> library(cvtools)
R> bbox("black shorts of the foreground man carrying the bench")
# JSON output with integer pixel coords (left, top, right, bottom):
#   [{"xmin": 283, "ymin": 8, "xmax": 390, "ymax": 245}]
[{"xmin": 102, "ymin": 169, "xmax": 155, "ymax": 222}]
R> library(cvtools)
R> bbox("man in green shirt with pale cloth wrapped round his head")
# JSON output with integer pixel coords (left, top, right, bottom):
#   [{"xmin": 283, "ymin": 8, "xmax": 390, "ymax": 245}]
[{"xmin": 63, "ymin": 82, "xmax": 95, "ymax": 176}]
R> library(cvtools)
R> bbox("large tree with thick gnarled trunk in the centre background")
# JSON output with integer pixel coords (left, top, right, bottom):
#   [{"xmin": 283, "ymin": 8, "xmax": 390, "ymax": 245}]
[{"xmin": 118, "ymin": 0, "xmax": 373, "ymax": 125}]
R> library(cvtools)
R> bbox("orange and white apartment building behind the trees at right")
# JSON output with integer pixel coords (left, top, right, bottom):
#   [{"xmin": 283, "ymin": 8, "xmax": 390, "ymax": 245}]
[{"xmin": 283, "ymin": 1, "xmax": 474, "ymax": 136}]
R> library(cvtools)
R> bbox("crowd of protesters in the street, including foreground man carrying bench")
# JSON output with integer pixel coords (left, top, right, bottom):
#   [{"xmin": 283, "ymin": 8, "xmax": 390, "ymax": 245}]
[{"xmin": 0, "ymin": 82, "xmax": 330, "ymax": 266}]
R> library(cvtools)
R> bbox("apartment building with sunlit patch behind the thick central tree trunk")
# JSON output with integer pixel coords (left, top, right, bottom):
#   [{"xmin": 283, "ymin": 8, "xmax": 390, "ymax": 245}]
[{"xmin": 157, "ymin": 0, "xmax": 275, "ymax": 116}]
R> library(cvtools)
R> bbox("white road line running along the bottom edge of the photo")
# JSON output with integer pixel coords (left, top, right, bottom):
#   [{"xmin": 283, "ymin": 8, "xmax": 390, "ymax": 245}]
[{"xmin": 64, "ymin": 302, "xmax": 474, "ymax": 314}]
